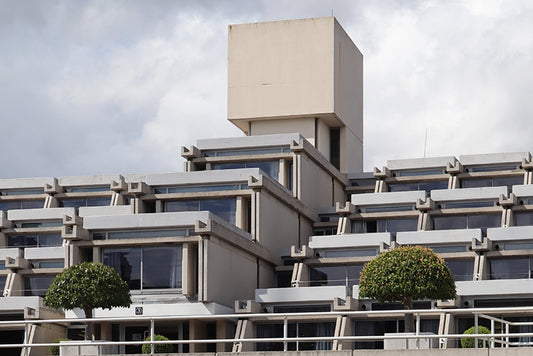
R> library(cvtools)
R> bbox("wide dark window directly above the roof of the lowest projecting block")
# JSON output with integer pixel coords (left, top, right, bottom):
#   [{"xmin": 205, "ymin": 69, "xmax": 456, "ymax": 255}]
[{"xmin": 165, "ymin": 198, "xmax": 237, "ymax": 224}]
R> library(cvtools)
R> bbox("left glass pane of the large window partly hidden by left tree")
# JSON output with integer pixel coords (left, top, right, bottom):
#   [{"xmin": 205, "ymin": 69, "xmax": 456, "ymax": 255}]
[{"xmin": 103, "ymin": 247, "xmax": 141, "ymax": 289}]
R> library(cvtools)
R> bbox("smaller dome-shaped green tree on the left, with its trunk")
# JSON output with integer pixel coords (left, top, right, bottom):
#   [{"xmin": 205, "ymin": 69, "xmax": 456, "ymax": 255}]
[{"xmin": 44, "ymin": 262, "xmax": 131, "ymax": 340}]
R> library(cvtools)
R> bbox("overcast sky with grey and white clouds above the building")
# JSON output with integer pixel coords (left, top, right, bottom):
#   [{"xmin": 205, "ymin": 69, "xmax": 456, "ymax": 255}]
[{"xmin": 0, "ymin": 0, "xmax": 533, "ymax": 178}]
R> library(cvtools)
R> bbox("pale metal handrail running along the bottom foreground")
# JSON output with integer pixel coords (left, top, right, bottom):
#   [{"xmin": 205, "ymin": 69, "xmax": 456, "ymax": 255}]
[{"xmin": 0, "ymin": 307, "xmax": 533, "ymax": 352}]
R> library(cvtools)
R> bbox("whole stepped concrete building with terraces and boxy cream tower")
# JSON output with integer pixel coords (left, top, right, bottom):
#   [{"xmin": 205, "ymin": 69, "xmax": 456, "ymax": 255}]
[{"xmin": 0, "ymin": 17, "xmax": 533, "ymax": 355}]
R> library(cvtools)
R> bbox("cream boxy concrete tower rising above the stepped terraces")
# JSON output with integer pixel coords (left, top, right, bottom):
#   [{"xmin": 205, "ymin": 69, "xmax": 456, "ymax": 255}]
[{"xmin": 228, "ymin": 17, "xmax": 363, "ymax": 172}]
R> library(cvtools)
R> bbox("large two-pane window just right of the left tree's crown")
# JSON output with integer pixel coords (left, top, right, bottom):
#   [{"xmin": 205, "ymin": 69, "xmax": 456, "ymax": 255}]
[{"xmin": 103, "ymin": 246, "xmax": 182, "ymax": 290}]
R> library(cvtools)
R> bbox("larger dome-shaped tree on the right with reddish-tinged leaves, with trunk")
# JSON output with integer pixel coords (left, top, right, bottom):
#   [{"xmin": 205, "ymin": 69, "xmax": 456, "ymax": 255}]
[{"xmin": 359, "ymin": 246, "xmax": 456, "ymax": 331}]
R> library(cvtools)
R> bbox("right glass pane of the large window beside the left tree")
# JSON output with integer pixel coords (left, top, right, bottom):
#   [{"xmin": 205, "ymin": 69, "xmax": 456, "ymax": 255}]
[{"xmin": 143, "ymin": 246, "xmax": 182, "ymax": 289}]
